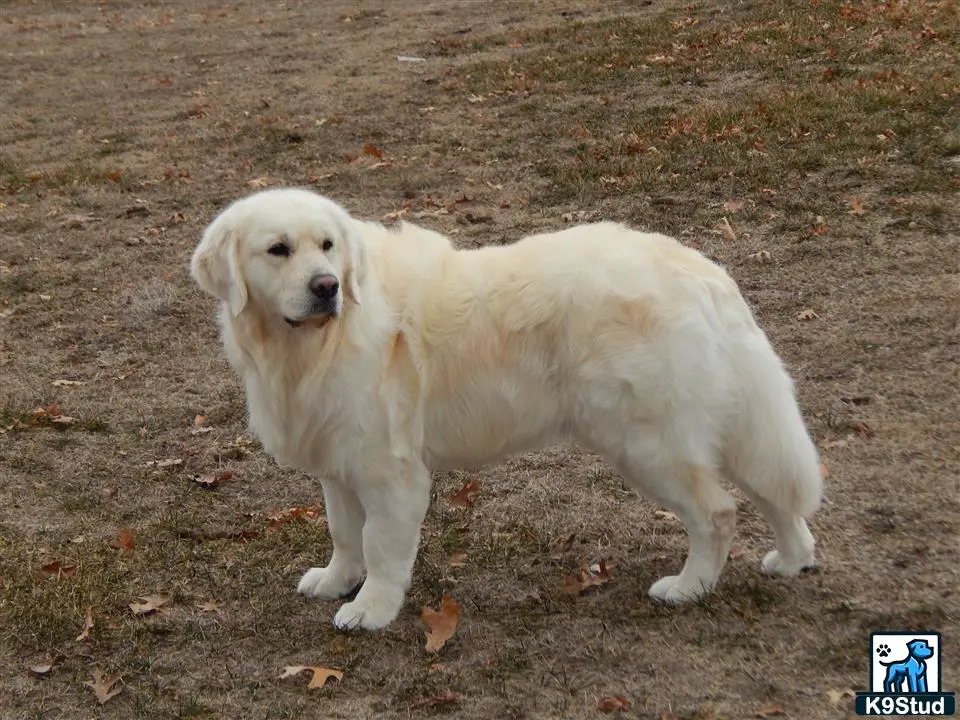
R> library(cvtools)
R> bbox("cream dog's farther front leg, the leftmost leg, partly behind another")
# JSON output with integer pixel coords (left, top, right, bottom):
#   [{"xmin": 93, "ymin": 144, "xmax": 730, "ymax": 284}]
[{"xmin": 297, "ymin": 480, "xmax": 364, "ymax": 600}]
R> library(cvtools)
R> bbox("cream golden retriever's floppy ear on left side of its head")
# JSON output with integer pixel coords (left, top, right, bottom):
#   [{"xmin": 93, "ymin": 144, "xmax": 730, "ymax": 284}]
[{"xmin": 190, "ymin": 209, "xmax": 247, "ymax": 317}]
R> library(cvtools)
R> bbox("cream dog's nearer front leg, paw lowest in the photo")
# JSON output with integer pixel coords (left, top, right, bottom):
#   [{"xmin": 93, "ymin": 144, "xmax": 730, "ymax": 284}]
[{"xmin": 333, "ymin": 458, "xmax": 430, "ymax": 630}]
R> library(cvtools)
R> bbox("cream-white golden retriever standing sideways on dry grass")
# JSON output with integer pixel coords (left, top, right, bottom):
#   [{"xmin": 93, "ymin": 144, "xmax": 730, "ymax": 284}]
[{"xmin": 190, "ymin": 188, "xmax": 822, "ymax": 630}]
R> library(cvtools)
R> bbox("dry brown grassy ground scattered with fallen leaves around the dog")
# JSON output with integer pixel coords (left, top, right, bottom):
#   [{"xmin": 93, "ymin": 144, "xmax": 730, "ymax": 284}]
[{"xmin": 0, "ymin": 0, "xmax": 960, "ymax": 720}]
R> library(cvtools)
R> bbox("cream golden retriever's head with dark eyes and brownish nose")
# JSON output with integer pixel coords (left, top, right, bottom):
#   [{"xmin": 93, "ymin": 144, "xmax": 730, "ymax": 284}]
[{"xmin": 190, "ymin": 188, "xmax": 365, "ymax": 327}]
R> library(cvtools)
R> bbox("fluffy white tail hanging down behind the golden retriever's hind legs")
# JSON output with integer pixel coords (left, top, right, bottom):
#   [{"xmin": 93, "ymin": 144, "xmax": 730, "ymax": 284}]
[{"xmin": 724, "ymin": 323, "xmax": 823, "ymax": 517}]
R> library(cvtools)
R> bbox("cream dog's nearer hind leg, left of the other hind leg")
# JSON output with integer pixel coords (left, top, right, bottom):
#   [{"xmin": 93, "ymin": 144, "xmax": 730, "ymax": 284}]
[{"xmin": 617, "ymin": 451, "xmax": 737, "ymax": 605}]
